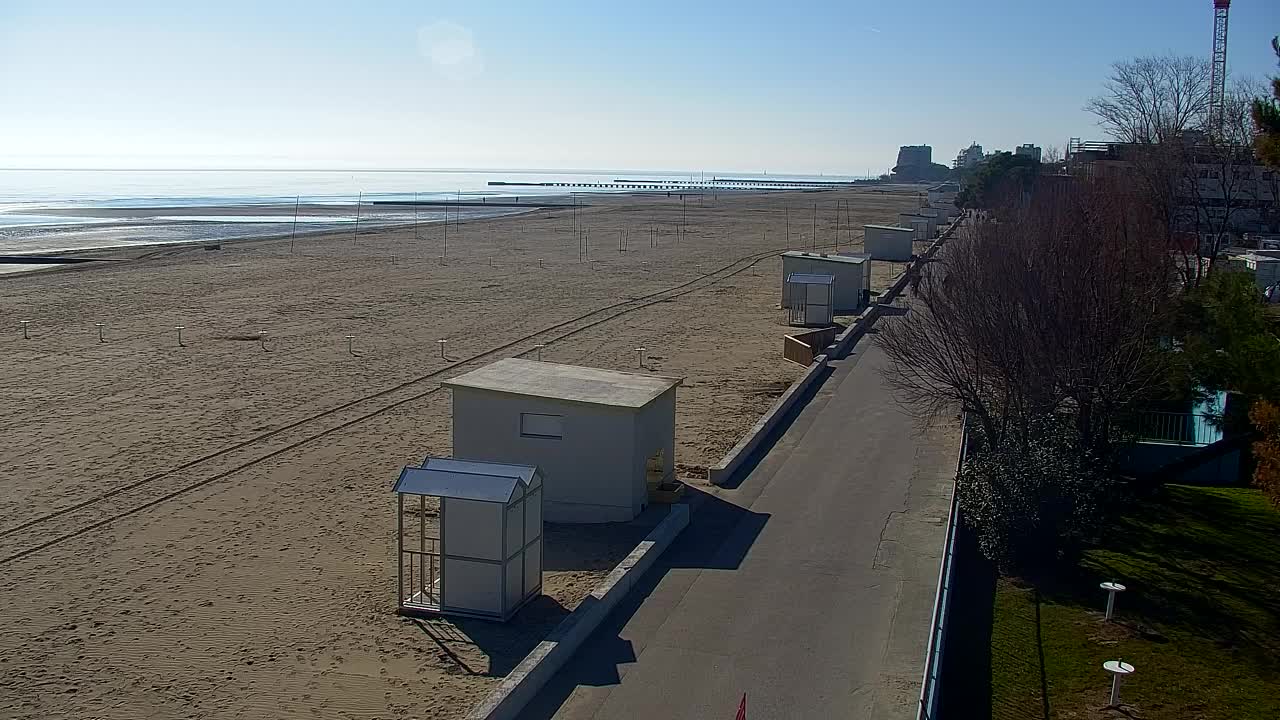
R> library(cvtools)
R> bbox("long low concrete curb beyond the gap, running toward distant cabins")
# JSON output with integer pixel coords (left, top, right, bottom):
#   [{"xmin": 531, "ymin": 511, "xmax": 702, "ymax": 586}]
[{"xmin": 707, "ymin": 210, "xmax": 963, "ymax": 486}]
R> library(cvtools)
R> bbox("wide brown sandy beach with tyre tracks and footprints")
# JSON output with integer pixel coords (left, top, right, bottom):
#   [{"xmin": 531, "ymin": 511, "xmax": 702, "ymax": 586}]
[{"xmin": 0, "ymin": 187, "xmax": 919, "ymax": 719}]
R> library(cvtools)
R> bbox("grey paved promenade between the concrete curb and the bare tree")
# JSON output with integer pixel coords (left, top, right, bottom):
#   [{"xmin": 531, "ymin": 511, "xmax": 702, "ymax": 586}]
[{"xmin": 524, "ymin": 340, "xmax": 959, "ymax": 720}]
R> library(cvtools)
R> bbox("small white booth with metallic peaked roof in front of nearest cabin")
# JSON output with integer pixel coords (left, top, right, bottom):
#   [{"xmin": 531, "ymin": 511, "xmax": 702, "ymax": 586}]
[{"xmin": 394, "ymin": 457, "xmax": 543, "ymax": 620}]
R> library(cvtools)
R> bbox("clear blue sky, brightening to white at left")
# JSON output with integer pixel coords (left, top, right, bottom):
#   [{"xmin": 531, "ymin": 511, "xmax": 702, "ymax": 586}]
[{"xmin": 0, "ymin": 0, "xmax": 1280, "ymax": 174}]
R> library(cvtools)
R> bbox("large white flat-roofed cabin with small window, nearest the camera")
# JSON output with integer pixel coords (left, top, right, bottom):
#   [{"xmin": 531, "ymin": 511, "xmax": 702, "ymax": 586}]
[{"xmin": 443, "ymin": 357, "xmax": 681, "ymax": 523}]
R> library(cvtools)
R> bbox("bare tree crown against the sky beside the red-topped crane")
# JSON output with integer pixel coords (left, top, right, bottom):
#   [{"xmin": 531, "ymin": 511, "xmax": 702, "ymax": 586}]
[{"xmin": 1084, "ymin": 55, "xmax": 1211, "ymax": 142}]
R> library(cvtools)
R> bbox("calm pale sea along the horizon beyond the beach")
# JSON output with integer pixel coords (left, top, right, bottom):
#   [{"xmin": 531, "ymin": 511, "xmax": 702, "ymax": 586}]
[{"xmin": 0, "ymin": 169, "xmax": 870, "ymax": 255}]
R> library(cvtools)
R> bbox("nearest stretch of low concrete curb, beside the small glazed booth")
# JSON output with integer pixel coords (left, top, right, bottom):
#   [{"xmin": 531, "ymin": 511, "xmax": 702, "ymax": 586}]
[{"xmin": 466, "ymin": 503, "xmax": 690, "ymax": 720}]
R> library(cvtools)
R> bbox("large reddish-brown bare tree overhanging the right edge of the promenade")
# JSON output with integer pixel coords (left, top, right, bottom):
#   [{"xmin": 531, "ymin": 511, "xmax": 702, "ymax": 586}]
[{"xmin": 879, "ymin": 178, "xmax": 1171, "ymax": 452}]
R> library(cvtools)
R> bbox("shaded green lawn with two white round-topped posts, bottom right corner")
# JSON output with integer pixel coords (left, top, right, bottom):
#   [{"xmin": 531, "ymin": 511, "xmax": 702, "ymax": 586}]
[{"xmin": 991, "ymin": 486, "xmax": 1280, "ymax": 720}]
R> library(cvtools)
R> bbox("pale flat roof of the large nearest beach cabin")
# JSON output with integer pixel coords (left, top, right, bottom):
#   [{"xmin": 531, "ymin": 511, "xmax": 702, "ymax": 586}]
[{"xmin": 440, "ymin": 357, "xmax": 682, "ymax": 407}]
